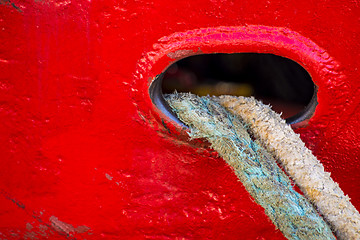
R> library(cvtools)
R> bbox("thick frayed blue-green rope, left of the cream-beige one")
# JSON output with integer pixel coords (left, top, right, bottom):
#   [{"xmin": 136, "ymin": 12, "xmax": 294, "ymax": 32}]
[{"xmin": 166, "ymin": 93, "xmax": 335, "ymax": 240}]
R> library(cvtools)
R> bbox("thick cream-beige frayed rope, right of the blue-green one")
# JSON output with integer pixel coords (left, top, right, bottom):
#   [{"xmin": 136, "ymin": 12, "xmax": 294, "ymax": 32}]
[{"xmin": 217, "ymin": 96, "xmax": 360, "ymax": 240}]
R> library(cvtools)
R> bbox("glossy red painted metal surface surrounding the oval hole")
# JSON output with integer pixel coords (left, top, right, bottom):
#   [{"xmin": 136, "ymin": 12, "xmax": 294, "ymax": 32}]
[{"xmin": 0, "ymin": 0, "xmax": 360, "ymax": 239}]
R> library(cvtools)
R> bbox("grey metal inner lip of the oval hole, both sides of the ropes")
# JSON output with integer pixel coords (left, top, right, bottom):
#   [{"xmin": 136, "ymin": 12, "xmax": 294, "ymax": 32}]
[{"xmin": 149, "ymin": 73, "xmax": 318, "ymax": 126}]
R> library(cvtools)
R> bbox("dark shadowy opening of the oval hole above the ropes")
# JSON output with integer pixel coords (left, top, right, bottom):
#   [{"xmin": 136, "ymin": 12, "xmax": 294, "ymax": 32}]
[{"xmin": 162, "ymin": 53, "xmax": 316, "ymax": 123}]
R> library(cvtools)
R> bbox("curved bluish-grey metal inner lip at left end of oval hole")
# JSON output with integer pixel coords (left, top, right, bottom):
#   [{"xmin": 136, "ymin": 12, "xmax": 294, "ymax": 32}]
[{"xmin": 149, "ymin": 73, "xmax": 188, "ymax": 129}]
